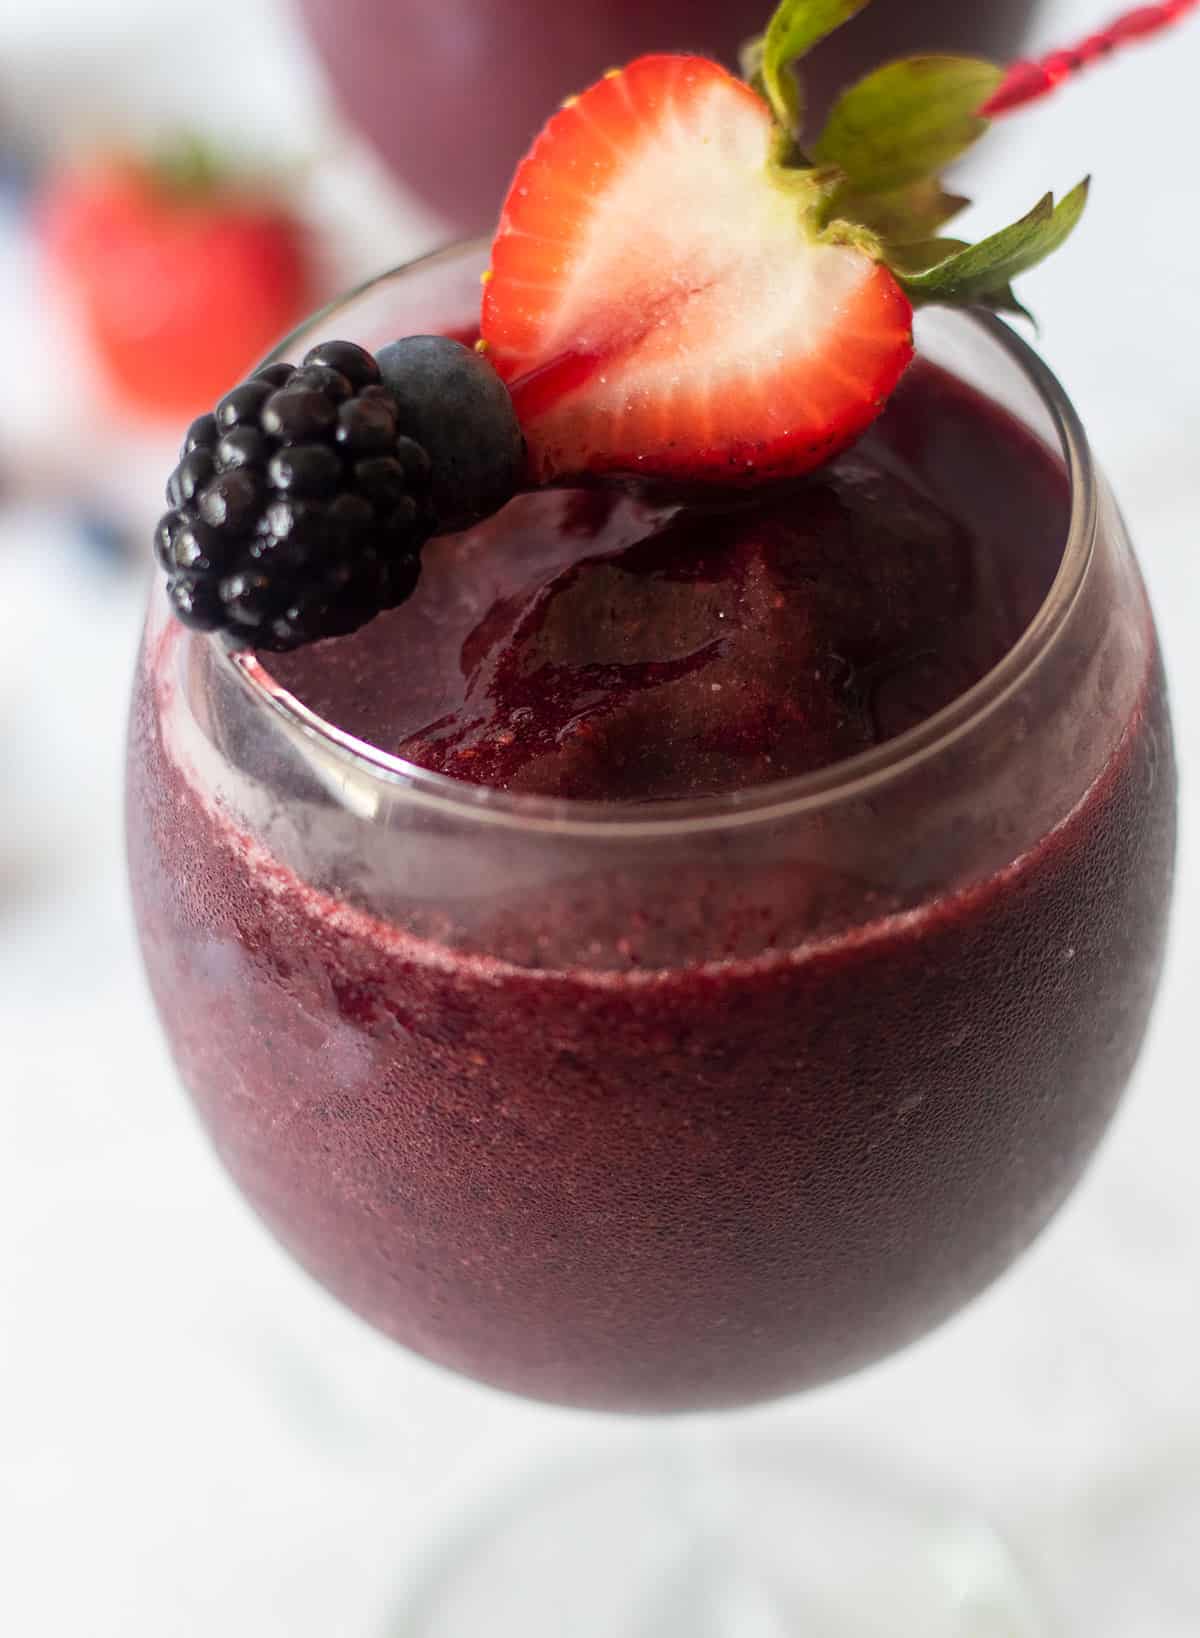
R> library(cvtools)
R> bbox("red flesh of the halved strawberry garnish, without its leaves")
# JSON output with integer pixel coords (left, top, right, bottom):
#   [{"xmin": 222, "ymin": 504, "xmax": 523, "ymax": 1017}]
[{"xmin": 481, "ymin": 56, "xmax": 912, "ymax": 483}]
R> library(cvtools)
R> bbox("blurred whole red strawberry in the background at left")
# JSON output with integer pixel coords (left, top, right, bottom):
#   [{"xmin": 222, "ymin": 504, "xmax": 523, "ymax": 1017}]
[{"xmin": 39, "ymin": 139, "xmax": 318, "ymax": 419}]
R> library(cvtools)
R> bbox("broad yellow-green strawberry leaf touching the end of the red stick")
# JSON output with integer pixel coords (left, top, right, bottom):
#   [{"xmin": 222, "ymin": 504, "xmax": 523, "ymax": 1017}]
[{"xmin": 815, "ymin": 55, "xmax": 1004, "ymax": 193}]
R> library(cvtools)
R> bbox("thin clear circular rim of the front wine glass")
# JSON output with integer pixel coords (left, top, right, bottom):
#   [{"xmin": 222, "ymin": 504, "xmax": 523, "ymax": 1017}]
[{"xmin": 210, "ymin": 239, "xmax": 1097, "ymax": 840}]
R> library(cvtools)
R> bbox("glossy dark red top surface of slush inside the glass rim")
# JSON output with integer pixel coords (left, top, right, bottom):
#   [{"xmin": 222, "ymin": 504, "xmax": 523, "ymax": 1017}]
[{"xmin": 268, "ymin": 364, "xmax": 1067, "ymax": 801}]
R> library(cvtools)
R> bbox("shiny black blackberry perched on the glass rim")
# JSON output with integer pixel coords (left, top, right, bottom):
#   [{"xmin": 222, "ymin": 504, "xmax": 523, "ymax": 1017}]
[{"xmin": 154, "ymin": 344, "xmax": 434, "ymax": 650}]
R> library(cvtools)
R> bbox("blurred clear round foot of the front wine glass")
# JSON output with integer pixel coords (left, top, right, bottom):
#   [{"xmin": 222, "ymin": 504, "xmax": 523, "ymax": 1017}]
[{"xmin": 391, "ymin": 1433, "xmax": 1051, "ymax": 1638}]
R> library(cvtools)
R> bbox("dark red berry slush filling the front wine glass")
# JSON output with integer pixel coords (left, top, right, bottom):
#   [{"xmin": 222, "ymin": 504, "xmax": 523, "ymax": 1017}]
[{"xmin": 129, "ymin": 372, "xmax": 1174, "ymax": 1409}]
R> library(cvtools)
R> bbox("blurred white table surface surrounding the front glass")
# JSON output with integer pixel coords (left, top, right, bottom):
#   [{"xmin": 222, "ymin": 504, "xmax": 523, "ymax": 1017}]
[{"xmin": 0, "ymin": 0, "xmax": 1200, "ymax": 1638}]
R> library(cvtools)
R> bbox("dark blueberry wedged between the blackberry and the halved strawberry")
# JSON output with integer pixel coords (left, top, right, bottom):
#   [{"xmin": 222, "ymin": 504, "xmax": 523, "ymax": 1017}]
[{"xmin": 378, "ymin": 336, "xmax": 524, "ymax": 529}]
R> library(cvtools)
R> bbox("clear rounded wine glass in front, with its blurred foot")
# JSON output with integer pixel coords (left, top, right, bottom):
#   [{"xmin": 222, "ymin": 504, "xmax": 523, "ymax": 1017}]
[{"xmin": 128, "ymin": 246, "xmax": 1175, "ymax": 1638}]
